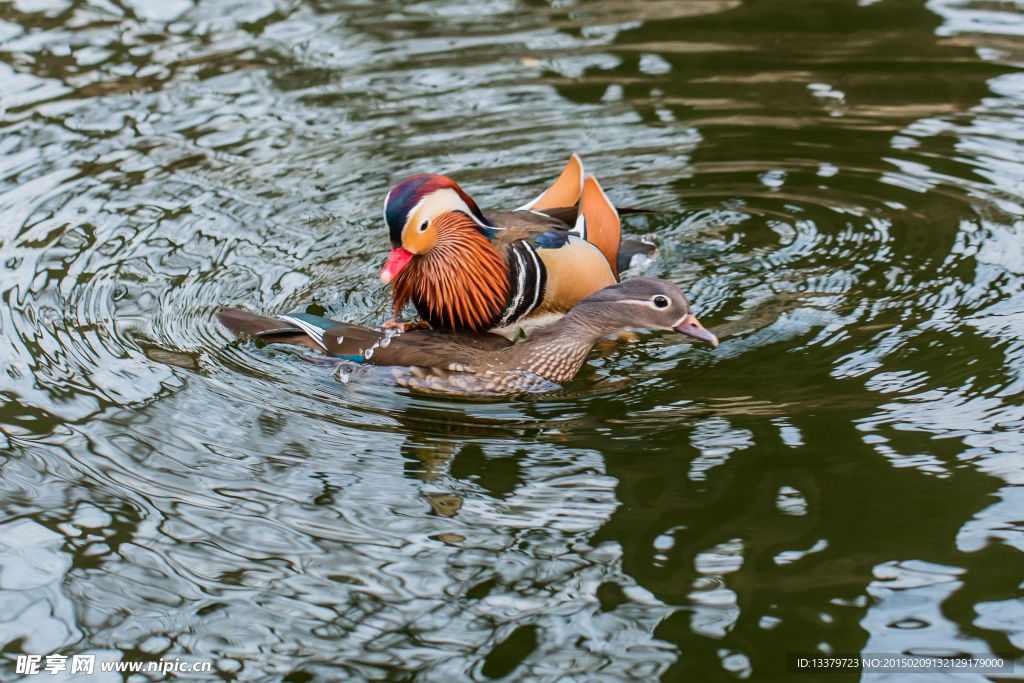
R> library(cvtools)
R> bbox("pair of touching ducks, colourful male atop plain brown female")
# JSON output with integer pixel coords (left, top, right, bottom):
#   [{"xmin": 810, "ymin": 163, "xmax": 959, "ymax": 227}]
[{"xmin": 217, "ymin": 155, "xmax": 718, "ymax": 395}]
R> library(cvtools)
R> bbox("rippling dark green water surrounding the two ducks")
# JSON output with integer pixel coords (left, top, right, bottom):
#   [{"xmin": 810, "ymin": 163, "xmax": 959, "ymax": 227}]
[{"xmin": 6, "ymin": 0, "xmax": 1024, "ymax": 683}]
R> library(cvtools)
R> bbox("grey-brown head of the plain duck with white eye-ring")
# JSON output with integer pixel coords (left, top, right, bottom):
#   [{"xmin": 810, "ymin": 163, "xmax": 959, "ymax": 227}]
[{"xmin": 566, "ymin": 278, "xmax": 718, "ymax": 346}]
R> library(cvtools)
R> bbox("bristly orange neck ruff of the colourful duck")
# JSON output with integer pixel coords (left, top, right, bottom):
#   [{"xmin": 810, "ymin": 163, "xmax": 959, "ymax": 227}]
[{"xmin": 392, "ymin": 212, "xmax": 509, "ymax": 331}]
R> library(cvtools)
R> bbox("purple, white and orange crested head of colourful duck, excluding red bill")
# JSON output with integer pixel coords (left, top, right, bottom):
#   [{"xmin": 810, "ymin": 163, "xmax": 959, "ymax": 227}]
[{"xmin": 384, "ymin": 173, "xmax": 490, "ymax": 254}]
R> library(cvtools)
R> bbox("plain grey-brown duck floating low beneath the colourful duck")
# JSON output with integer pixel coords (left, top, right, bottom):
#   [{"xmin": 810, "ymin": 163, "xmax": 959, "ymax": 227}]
[{"xmin": 217, "ymin": 278, "xmax": 718, "ymax": 396}]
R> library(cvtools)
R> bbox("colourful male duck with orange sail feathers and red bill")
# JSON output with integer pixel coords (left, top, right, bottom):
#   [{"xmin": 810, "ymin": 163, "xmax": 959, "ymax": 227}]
[{"xmin": 381, "ymin": 155, "xmax": 648, "ymax": 339}]
